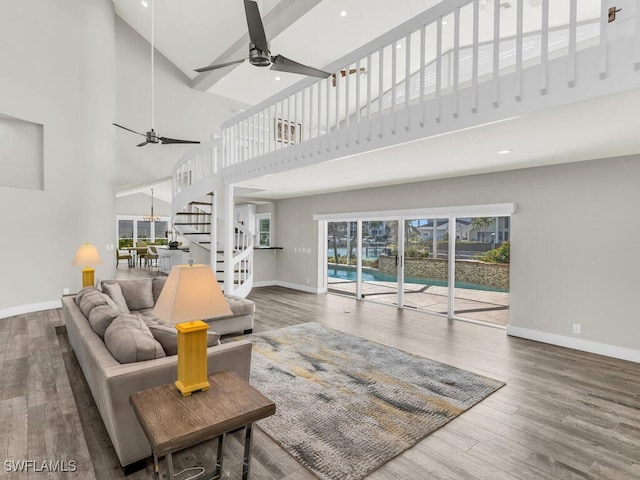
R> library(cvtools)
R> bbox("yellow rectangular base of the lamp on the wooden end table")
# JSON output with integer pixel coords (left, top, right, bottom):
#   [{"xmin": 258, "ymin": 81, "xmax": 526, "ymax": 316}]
[{"xmin": 175, "ymin": 320, "xmax": 209, "ymax": 397}]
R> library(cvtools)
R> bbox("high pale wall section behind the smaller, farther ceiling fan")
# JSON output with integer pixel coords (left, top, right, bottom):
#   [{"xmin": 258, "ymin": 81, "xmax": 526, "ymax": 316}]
[{"xmin": 111, "ymin": 17, "xmax": 247, "ymax": 186}]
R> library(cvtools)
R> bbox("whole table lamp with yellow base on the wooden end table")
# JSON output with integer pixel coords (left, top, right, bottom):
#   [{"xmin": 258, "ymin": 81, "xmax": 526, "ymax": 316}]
[{"xmin": 153, "ymin": 260, "xmax": 232, "ymax": 396}]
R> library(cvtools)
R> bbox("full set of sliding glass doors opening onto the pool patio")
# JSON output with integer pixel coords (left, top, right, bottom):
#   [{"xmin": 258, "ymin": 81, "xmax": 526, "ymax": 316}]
[{"xmin": 326, "ymin": 204, "xmax": 513, "ymax": 326}]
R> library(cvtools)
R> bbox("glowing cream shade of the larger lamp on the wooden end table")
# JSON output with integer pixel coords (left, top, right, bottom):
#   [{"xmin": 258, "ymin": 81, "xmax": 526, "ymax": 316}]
[{"xmin": 153, "ymin": 265, "xmax": 232, "ymax": 323}]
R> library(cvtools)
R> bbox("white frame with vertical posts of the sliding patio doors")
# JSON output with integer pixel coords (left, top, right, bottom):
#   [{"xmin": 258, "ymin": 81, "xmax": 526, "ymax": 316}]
[{"xmin": 313, "ymin": 203, "xmax": 516, "ymax": 321}]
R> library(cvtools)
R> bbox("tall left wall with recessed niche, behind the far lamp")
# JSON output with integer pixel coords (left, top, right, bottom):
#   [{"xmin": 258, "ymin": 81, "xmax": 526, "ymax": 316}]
[{"xmin": 0, "ymin": 0, "xmax": 116, "ymax": 317}]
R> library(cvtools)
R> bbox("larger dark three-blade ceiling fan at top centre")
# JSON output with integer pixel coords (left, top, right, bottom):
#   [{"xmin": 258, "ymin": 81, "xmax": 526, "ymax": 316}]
[{"xmin": 195, "ymin": 0, "xmax": 331, "ymax": 78}]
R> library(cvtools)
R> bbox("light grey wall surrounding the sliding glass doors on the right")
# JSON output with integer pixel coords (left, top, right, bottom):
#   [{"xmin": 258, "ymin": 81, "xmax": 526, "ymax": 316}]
[{"xmin": 275, "ymin": 156, "xmax": 640, "ymax": 361}]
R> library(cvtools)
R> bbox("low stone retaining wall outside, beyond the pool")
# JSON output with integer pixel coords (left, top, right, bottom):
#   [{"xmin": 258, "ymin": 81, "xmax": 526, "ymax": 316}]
[{"xmin": 378, "ymin": 255, "xmax": 509, "ymax": 290}]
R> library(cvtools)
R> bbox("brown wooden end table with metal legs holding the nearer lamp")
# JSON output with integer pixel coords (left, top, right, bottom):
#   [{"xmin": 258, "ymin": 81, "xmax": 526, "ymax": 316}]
[{"xmin": 129, "ymin": 370, "xmax": 276, "ymax": 480}]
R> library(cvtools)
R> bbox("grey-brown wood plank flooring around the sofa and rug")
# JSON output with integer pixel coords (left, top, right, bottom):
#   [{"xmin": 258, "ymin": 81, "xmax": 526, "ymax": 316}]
[{"xmin": 0, "ymin": 287, "xmax": 640, "ymax": 480}]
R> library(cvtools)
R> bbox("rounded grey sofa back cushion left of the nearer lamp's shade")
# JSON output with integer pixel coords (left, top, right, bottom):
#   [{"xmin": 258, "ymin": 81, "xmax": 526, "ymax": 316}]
[{"xmin": 104, "ymin": 313, "xmax": 166, "ymax": 363}]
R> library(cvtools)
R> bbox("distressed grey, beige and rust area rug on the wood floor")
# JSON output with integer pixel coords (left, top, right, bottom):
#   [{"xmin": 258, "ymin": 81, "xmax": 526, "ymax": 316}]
[{"xmin": 249, "ymin": 323, "xmax": 504, "ymax": 480}]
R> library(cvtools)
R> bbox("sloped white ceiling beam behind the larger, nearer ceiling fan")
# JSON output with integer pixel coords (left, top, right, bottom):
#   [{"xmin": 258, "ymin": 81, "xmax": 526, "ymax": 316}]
[{"xmin": 191, "ymin": 0, "xmax": 322, "ymax": 92}]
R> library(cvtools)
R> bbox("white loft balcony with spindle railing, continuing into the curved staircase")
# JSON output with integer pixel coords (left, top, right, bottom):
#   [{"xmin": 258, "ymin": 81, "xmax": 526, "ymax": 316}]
[{"xmin": 173, "ymin": 0, "xmax": 640, "ymax": 293}]
